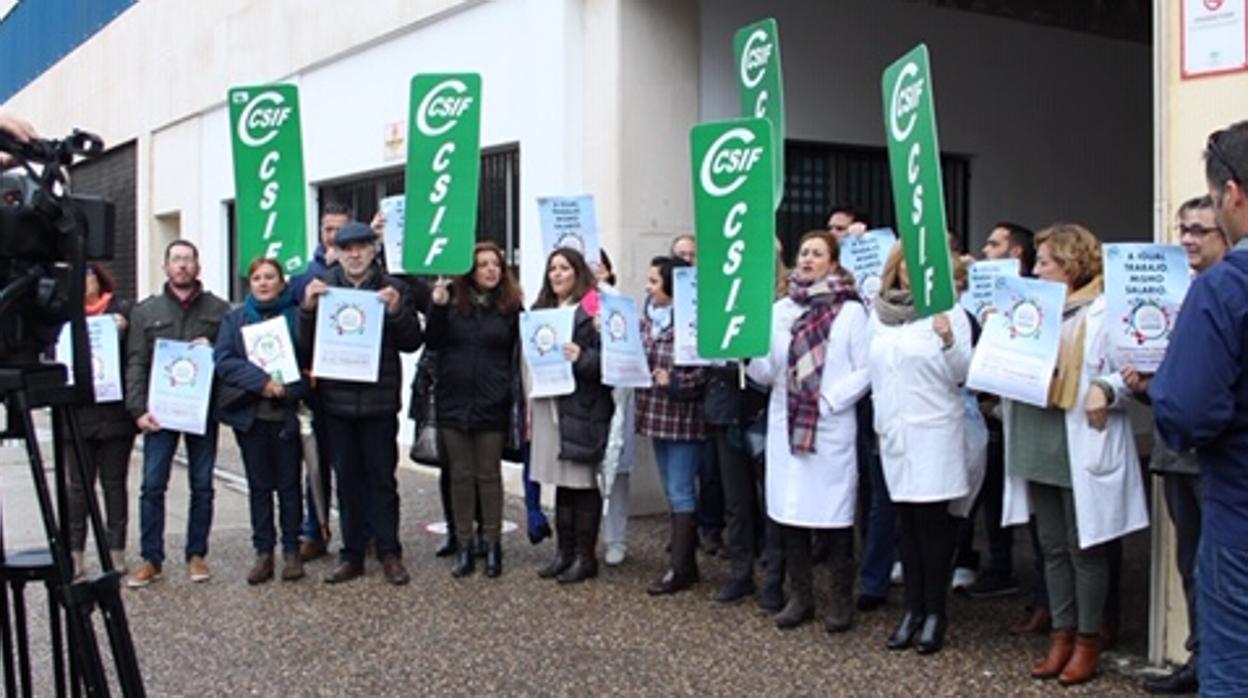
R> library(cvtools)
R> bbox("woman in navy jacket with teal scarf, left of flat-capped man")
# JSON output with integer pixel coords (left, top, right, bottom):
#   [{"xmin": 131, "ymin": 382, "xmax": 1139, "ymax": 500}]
[{"xmin": 213, "ymin": 258, "xmax": 307, "ymax": 584}]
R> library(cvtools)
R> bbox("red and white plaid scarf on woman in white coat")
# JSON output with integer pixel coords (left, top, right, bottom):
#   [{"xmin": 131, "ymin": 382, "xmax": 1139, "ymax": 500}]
[{"xmin": 787, "ymin": 270, "xmax": 857, "ymax": 456}]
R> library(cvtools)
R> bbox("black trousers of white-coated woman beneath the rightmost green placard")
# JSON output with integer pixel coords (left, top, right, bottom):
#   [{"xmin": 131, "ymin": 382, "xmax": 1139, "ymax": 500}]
[{"xmin": 894, "ymin": 502, "xmax": 956, "ymax": 616}]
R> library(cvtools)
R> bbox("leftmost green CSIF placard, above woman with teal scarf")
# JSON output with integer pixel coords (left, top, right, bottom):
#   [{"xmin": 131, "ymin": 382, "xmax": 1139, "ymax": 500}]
[{"xmin": 226, "ymin": 85, "xmax": 308, "ymax": 276}]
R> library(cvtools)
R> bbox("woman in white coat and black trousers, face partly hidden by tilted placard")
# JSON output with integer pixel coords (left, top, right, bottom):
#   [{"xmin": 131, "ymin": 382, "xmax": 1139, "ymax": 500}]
[{"xmin": 871, "ymin": 245, "xmax": 971, "ymax": 654}]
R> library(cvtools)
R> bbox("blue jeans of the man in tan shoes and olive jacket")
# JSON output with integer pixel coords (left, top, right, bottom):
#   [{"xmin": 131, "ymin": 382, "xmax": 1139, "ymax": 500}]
[{"xmin": 139, "ymin": 427, "xmax": 217, "ymax": 564}]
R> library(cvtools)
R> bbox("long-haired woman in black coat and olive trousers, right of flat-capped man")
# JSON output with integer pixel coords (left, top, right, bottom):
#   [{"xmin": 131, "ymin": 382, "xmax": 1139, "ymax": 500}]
[{"xmin": 426, "ymin": 242, "xmax": 520, "ymax": 577}]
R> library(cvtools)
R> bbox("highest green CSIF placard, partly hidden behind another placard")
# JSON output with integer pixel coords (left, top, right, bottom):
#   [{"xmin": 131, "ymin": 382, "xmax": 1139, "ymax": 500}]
[{"xmin": 733, "ymin": 17, "xmax": 784, "ymax": 207}]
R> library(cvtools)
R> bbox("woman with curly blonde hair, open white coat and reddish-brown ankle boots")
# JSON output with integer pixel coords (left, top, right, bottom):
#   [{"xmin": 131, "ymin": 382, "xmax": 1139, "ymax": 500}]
[{"xmin": 1003, "ymin": 224, "xmax": 1148, "ymax": 686}]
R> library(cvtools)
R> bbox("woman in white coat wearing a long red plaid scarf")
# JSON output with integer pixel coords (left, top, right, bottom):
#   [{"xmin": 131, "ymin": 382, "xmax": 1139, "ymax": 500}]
[{"xmin": 749, "ymin": 230, "xmax": 867, "ymax": 633}]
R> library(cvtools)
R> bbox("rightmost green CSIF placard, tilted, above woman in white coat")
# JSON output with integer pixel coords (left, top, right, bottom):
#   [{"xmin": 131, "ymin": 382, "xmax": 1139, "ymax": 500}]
[{"xmin": 882, "ymin": 44, "xmax": 957, "ymax": 317}]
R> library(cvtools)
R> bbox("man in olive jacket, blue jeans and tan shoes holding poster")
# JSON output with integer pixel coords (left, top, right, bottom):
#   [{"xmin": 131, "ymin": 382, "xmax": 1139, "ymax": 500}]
[{"xmin": 126, "ymin": 240, "xmax": 230, "ymax": 587}]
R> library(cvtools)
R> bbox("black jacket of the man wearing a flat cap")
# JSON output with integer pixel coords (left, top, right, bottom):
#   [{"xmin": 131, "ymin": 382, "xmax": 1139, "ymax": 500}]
[{"xmin": 298, "ymin": 263, "xmax": 424, "ymax": 420}]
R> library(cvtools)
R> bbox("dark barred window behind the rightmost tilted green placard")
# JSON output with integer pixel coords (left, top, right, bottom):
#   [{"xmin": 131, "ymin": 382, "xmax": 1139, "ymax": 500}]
[{"xmin": 776, "ymin": 141, "xmax": 971, "ymax": 261}]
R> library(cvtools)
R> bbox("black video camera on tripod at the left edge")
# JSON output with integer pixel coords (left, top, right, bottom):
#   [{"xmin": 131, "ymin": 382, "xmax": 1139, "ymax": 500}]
[{"xmin": 0, "ymin": 130, "xmax": 115, "ymax": 374}]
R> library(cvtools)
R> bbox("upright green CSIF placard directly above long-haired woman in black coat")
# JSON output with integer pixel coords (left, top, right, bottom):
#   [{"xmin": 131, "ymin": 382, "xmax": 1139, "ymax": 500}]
[{"xmin": 403, "ymin": 72, "xmax": 480, "ymax": 275}]
